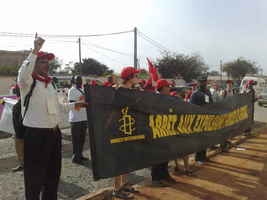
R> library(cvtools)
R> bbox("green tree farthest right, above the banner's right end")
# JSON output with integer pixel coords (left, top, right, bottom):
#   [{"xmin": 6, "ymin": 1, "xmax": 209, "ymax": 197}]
[{"xmin": 223, "ymin": 58, "xmax": 259, "ymax": 80}]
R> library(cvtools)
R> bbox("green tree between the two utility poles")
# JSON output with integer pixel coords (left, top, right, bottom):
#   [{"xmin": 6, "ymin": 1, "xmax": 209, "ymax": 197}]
[{"xmin": 74, "ymin": 58, "xmax": 113, "ymax": 76}]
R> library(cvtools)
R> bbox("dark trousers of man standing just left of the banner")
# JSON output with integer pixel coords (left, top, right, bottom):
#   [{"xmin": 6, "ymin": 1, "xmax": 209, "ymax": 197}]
[{"xmin": 71, "ymin": 121, "xmax": 87, "ymax": 159}]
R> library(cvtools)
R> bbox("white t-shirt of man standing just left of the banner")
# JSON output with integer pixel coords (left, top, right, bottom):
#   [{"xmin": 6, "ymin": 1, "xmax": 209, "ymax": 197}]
[{"xmin": 68, "ymin": 86, "xmax": 87, "ymax": 122}]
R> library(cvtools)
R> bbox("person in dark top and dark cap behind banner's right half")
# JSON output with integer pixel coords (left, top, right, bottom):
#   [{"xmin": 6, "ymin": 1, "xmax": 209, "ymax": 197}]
[{"xmin": 190, "ymin": 76, "xmax": 213, "ymax": 165}]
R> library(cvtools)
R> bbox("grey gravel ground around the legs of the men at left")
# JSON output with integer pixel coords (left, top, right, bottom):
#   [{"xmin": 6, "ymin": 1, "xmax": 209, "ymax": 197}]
[{"xmin": 0, "ymin": 129, "xmax": 150, "ymax": 200}]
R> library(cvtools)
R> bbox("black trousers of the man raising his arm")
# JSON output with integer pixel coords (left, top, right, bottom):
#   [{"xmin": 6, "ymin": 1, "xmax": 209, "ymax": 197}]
[{"xmin": 24, "ymin": 127, "xmax": 62, "ymax": 200}]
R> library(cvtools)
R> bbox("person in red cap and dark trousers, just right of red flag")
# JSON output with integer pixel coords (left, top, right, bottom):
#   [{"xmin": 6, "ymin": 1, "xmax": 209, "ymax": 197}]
[{"xmin": 151, "ymin": 79, "xmax": 176, "ymax": 187}]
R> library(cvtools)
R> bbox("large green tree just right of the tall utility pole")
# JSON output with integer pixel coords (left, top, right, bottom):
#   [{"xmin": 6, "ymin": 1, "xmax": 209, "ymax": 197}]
[{"xmin": 156, "ymin": 54, "xmax": 208, "ymax": 82}]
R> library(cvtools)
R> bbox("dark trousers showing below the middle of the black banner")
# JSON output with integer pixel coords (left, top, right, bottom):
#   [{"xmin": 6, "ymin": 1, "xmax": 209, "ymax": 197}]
[{"xmin": 151, "ymin": 162, "xmax": 170, "ymax": 181}]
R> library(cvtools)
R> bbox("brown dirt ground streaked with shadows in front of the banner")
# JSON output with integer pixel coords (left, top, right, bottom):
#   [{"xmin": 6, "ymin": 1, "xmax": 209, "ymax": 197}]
[{"xmin": 135, "ymin": 130, "xmax": 267, "ymax": 200}]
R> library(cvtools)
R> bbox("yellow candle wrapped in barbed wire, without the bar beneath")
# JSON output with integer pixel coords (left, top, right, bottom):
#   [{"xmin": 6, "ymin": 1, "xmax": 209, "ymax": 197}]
[{"xmin": 119, "ymin": 107, "xmax": 135, "ymax": 135}]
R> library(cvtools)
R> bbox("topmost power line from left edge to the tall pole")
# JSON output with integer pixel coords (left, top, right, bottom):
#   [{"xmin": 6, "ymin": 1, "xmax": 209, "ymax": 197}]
[{"xmin": 0, "ymin": 30, "xmax": 133, "ymax": 38}]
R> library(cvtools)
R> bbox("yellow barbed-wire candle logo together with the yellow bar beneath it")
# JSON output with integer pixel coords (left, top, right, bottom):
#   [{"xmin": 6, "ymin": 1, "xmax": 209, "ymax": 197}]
[{"xmin": 110, "ymin": 107, "xmax": 145, "ymax": 144}]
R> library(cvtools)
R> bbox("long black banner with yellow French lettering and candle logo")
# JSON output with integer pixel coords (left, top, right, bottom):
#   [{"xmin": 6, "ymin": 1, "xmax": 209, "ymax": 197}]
[{"xmin": 85, "ymin": 86, "xmax": 253, "ymax": 180}]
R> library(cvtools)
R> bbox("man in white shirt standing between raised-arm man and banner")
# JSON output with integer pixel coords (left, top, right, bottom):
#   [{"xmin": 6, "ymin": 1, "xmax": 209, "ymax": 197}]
[{"xmin": 68, "ymin": 76, "xmax": 88, "ymax": 164}]
